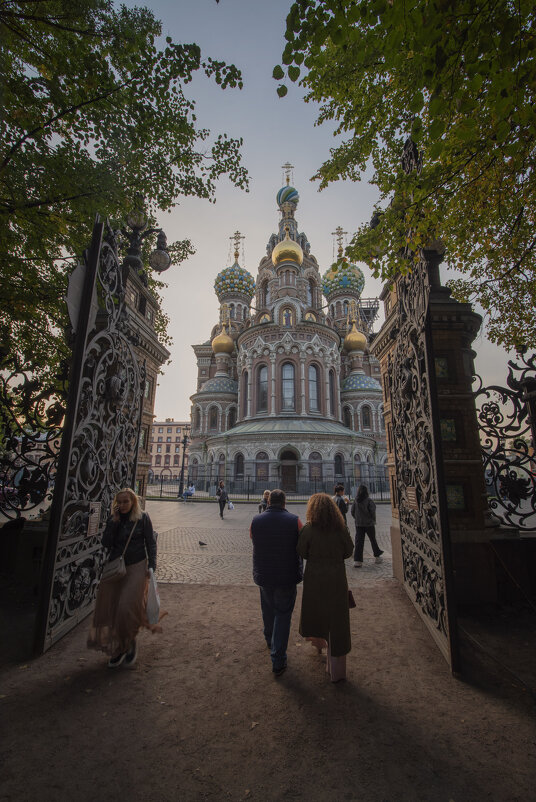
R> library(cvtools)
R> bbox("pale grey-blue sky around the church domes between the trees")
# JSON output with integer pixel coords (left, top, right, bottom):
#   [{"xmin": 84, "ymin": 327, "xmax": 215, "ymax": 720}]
[{"xmin": 125, "ymin": 0, "xmax": 513, "ymax": 421}]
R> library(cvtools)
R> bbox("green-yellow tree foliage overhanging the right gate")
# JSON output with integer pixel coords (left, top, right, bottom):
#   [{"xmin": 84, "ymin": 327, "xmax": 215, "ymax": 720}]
[{"xmin": 274, "ymin": 0, "xmax": 536, "ymax": 347}]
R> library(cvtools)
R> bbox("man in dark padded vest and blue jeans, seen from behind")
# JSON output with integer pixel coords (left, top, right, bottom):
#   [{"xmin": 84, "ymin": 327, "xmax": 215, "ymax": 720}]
[{"xmin": 250, "ymin": 490, "xmax": 303, "ymax": 677}]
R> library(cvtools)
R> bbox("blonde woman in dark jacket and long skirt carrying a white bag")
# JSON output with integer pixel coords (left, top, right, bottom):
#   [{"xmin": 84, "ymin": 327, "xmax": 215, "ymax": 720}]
[{"xmin": 87, "ymin": 487, "xmax": 160, "ymax": 668}]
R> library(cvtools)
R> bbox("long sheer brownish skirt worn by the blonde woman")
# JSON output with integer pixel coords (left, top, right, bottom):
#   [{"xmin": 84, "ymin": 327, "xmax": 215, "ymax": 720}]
[{"xmin": 87, "ymin": 560, "xmax": 151, "ymax": 657}]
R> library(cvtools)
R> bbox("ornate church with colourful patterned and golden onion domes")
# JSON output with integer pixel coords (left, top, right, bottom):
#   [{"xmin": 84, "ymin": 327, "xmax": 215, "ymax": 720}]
[{"xmin": 189, "ymin": 177, "xmax": 388, "ymax": 495}]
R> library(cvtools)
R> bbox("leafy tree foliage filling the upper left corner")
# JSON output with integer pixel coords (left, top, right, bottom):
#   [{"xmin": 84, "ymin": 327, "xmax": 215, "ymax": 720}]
[{"xmin": 0, "ymin": 0, "xmax": 247, "ymax": 380}]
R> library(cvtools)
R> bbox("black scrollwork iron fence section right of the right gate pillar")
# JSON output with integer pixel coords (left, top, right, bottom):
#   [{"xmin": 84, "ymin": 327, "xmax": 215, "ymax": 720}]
[{"xmin": 474, "ymin": 354, "xmax": 536, "ymax": 530}]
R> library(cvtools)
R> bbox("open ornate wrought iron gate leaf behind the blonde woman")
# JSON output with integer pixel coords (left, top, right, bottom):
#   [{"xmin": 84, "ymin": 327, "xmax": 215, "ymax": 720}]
[{"xmin": 35, "ymin": 219, "xmax": 145, "ymax": 653}]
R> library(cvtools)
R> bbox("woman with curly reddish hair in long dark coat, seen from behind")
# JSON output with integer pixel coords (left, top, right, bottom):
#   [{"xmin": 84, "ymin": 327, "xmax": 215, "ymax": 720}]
[{"xmin": 298, "ymin": 493, "xmax": 354, "ymax": 682}]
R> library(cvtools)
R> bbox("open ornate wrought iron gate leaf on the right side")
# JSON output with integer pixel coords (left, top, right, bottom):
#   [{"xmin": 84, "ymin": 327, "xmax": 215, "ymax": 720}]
[{"xmin": 390, "ymin": 253, "xmax": 459, "ymax": 671}]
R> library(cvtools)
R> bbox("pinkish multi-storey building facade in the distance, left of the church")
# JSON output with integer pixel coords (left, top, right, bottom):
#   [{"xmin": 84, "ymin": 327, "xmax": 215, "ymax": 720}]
[{"xmin": 149, "ymin": 418, "xmax": 190, "ymax": 484}]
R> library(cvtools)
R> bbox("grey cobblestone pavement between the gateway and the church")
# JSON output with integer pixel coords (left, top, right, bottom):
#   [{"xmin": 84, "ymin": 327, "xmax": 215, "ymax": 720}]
[{"xmin": 146, "ymin": 501, "xmax": 392, "ymax": 588}]
